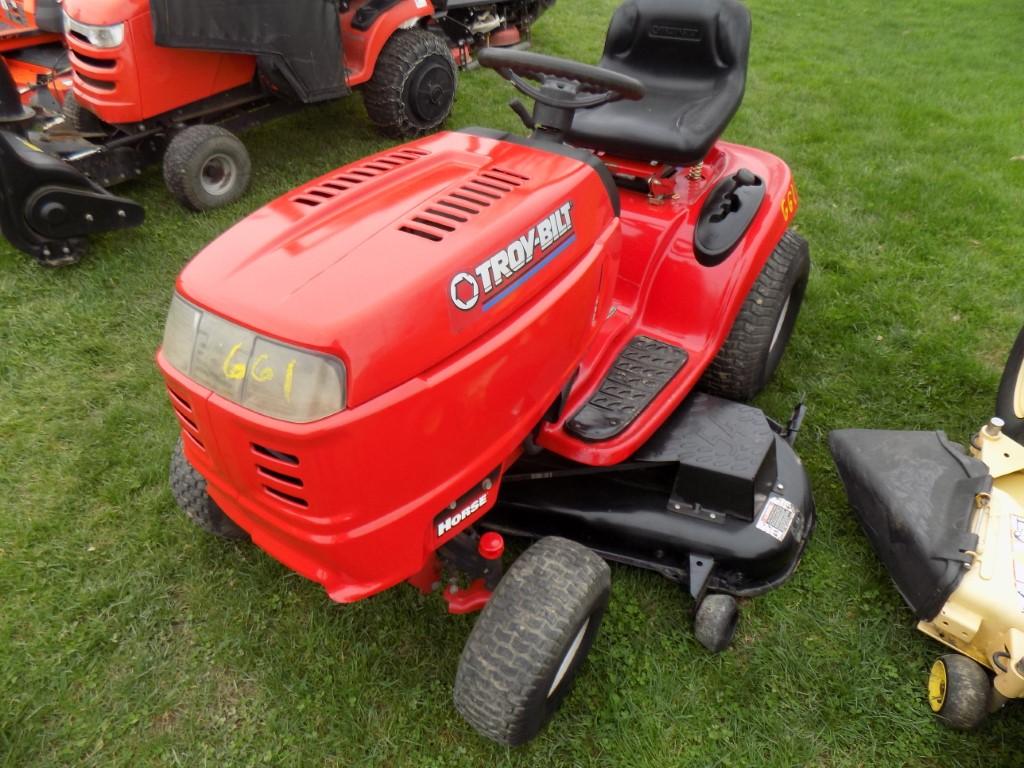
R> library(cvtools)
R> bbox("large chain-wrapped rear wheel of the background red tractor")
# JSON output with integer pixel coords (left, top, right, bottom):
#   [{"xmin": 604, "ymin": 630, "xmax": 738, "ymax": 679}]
[{"xmin": 362, "ymin": 29, "xmax": 458, "ymax": 138}]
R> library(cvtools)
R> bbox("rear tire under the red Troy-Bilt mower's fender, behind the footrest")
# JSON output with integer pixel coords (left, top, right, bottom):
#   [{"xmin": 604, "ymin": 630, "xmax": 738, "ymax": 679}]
[{"xmin": 700, "ymin": 229, "xmax": 811, "ymax": 400}]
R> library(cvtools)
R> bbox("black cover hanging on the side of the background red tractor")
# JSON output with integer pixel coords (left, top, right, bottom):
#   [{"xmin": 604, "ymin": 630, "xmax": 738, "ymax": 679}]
[{"xmin": 151, "ymin": 0, "xmax": 349, "ymax": 103}]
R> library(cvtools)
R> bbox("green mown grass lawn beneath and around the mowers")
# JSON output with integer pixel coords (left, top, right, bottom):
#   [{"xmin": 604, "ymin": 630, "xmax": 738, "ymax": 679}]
[{"xmin": 0, "ymin": 0, "xmax": 1024, "ymax": 768}]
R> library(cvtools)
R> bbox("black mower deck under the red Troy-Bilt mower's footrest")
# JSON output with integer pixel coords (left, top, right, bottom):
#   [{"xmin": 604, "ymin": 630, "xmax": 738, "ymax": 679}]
[{"xmin": 483, "ymin": 394, "xmax": 815, "ymax": 599}]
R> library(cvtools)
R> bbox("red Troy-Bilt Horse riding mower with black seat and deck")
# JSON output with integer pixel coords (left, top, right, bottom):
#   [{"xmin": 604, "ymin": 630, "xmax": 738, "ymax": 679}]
[{"xmin": 157, "ymin": 0, "xmax": 814, "ymax": 744}]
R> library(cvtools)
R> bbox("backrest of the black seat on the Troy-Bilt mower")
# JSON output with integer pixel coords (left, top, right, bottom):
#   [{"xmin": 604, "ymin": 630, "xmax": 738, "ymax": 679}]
[{"xmin": 601, "ymin": 0, "xmax": 751, "ymax": 91}]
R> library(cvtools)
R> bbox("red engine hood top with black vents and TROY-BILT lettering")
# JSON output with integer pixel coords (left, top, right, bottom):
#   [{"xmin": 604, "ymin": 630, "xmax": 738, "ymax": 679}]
[{"xmin": 178, "ymin": 133, "xmax": 614, "ymax": 406}]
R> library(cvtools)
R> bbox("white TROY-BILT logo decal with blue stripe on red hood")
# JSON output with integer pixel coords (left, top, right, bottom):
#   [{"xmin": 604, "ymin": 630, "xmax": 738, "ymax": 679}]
[{"xmin": 449, "ymin": 201, "xmax": 575, "ymax": 312}]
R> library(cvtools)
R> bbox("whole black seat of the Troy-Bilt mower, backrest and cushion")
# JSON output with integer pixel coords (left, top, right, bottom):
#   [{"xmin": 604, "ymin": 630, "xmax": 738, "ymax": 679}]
[{"xmin": 566, "ymin": 0, "xmax": 751, "ymax": 165}]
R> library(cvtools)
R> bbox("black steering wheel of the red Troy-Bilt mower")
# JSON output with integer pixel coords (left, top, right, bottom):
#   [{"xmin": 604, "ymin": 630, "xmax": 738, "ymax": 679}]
[{"xmin": 477, "ymin": 48, "xmax": 647, "ymax": 110}]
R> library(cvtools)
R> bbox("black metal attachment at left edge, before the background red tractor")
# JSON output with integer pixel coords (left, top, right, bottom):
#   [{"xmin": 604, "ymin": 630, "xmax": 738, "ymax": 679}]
[{"xmin": 0, "ymin": 62, "xmax": 144, "ymax": 266}]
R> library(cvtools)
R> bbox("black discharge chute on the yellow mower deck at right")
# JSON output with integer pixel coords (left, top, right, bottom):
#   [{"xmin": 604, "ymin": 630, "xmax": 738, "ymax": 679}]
[{"xmin": 828, "ymin": 429, "xmax": 992, "ymax": 622}]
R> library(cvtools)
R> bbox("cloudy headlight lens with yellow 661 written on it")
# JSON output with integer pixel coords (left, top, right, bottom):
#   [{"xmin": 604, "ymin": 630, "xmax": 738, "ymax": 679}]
[{"xmin": 163, "ymin": 295, "xmax": 345, "ymax": 423}]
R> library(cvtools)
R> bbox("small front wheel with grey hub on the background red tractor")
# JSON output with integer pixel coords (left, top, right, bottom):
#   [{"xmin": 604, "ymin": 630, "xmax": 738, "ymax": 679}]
[{"xmin": 164, "ymin": 125, "xmax": 252, "ymax": 211}]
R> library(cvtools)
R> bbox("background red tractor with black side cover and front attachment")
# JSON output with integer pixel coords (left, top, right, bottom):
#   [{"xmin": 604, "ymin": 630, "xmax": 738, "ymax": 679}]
[{"xmin": 0, "ymin": 0, "xmax": 553, "ymax": 266}]
